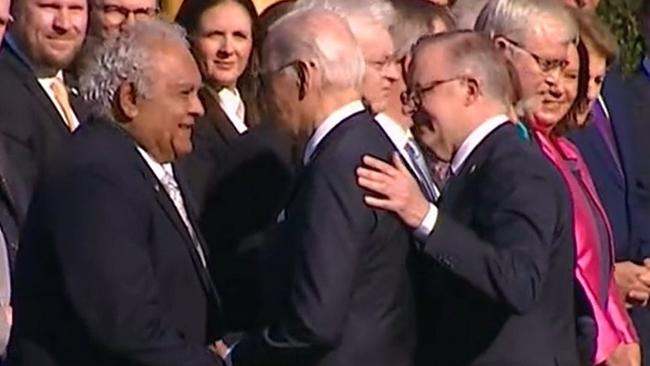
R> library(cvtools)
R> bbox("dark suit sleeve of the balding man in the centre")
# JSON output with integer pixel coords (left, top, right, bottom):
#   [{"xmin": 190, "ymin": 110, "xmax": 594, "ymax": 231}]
[{"xmin": 233, "ymin": 157, "xmax": 376, "ymax": 366}]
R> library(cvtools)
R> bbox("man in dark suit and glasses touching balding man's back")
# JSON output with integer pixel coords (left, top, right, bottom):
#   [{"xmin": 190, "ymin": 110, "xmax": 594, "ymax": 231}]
[{"xmin": 358, "ymin": 32, "xmax": 578, "ymax": 366}]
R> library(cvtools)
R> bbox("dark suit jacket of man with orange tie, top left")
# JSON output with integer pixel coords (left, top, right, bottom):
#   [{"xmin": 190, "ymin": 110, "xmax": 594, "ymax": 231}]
[{"xmin": 0, "ymin": 42, "xmax": 87, "ymax": 199}]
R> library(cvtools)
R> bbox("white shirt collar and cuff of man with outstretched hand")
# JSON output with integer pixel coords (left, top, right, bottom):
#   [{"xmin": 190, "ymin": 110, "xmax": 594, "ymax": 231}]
[{"xmin": 415, "ymin": 114, "xmax": 510, "ymax": 241}]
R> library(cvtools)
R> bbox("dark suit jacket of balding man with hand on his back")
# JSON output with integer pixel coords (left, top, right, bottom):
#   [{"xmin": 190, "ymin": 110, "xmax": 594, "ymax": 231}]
[{"xmin": 233, "ymin": 112, "xmax": 415, "ymax": 366}]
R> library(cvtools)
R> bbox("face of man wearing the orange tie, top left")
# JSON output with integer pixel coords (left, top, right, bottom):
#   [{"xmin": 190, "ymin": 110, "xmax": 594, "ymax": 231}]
[{"xmin": 11, "ymin": 0, "xmax": 88, "ymax": 76}]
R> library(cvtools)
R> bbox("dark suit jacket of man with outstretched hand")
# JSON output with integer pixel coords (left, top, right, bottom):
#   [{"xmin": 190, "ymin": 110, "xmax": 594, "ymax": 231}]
[{"xmin": 412, "ymin": 123, "xmax": 578, "ymax": 366}]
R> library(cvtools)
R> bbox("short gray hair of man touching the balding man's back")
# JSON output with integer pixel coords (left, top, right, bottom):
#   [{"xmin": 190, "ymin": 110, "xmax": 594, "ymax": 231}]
[{"xmin": 413, "ymin": 30, "xmax": 515, "ymax": 107}]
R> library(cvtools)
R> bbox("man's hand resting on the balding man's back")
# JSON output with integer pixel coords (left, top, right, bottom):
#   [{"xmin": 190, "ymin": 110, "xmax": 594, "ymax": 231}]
[{"xmin": 357, "ymin": 153, "xmax": 429, "ymax": 229}]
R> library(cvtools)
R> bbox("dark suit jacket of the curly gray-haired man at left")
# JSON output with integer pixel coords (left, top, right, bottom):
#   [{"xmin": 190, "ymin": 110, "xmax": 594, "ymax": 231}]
[{"xmin": 9, "ymin": 121, "xmax": 221, "ymax": 366}]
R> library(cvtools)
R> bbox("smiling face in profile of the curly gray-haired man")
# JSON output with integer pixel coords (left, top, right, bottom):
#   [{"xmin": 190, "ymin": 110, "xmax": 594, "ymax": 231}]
[{"xmin": 125, "ymin": 42, "xmax": 203, "ymax": 163}]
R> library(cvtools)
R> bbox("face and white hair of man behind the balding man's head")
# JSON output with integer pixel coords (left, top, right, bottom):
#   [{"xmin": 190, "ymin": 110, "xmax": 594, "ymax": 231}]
[{"xmin": 295, "ymin": 0, "xmax": 399, "ymax": 114}]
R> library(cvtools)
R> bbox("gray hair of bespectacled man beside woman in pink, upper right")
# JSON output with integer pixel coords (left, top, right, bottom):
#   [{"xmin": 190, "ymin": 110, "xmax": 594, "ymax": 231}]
[{"xmin": 474, "ymin": 0, "xmax": 578, "ymax": 43}]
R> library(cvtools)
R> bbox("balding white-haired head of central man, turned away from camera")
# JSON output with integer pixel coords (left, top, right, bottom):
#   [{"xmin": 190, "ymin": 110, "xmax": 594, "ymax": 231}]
[{"xmin": 262, "ymin": 8, "xmax": 365, "ymax": 137}]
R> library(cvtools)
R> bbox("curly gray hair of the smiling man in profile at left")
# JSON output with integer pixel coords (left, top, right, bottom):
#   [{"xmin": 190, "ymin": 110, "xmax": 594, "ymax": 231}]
[{"xmin": 79, "ymin": 19, "xmax": 189, "ymax": 119}]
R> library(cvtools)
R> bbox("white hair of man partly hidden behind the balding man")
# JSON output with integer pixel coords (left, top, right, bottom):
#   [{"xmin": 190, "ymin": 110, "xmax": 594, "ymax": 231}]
[{"xmin": 294, "ymin": 0, "xmax": 395, "ymax": 38}]
